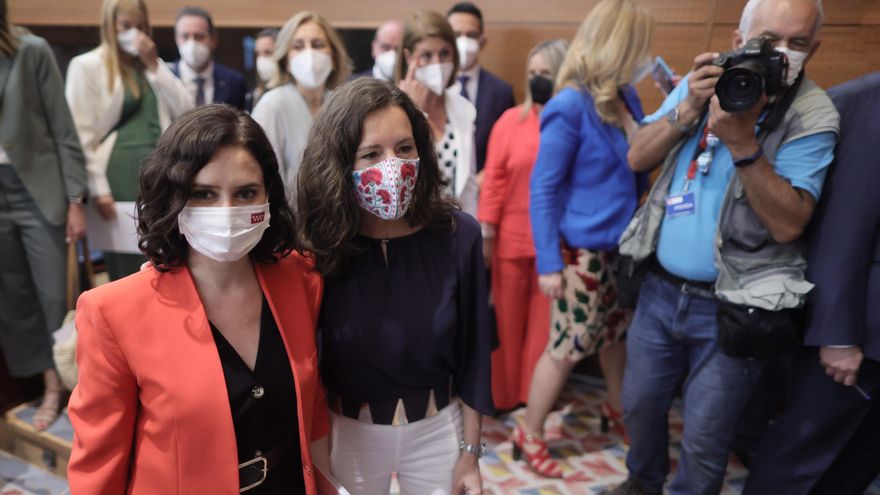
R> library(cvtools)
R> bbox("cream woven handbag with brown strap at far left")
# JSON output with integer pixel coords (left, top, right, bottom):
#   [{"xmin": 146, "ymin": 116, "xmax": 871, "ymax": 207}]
[{"xmin": 52, "ymin": 238, "xmax": 95, "ymax": 390}]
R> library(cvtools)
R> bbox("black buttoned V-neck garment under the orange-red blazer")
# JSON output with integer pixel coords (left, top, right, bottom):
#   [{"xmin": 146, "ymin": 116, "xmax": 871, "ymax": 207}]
[{"xmin": 211, "ymin": 298, "xmax": 306, "ymax": 495}]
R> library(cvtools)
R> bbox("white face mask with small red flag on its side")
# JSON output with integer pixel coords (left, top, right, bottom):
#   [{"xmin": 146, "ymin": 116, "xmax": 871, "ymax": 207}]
[{"xmin": 177, "ymin": 203, "xmax": 271, "ymax": 262}]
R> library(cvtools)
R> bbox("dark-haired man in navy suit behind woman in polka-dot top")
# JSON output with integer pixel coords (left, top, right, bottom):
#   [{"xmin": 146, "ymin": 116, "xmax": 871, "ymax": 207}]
[{"xmin": 446, "ymin": 2, "xmax": 515, "ymax": 171}]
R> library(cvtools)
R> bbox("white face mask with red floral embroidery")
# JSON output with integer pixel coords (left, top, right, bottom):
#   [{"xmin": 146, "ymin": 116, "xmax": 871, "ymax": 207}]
[{"xmin": 351, "ymin": 156, "xmax": 419, "ymax": 220}]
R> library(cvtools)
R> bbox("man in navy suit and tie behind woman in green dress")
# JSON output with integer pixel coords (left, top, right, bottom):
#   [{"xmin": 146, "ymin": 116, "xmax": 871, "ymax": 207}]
[{"xmin": 171, "ymin": 7, "xmax": 247, "ymax": 110}]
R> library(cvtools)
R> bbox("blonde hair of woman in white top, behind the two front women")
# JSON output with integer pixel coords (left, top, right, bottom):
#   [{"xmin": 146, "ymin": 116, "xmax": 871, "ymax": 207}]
[{"xmin": 269, "ymin": 10, "xmax": 351, "ymax": 89}]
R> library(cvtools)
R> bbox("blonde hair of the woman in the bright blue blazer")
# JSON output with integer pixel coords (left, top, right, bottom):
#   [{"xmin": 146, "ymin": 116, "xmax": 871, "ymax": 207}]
[{"xmin": 556, "ymin": 0, "xmax": 654, "ymax": 125}]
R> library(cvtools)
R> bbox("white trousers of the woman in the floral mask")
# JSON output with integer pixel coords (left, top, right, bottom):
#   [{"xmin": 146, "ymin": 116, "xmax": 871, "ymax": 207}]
[{"xmin": 330, "ymin": 400, "xmax": 462, "ymax": 495}]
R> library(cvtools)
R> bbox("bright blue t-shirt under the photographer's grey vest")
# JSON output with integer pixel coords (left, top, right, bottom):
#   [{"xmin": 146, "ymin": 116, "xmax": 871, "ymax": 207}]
[{"xmin": 642, "ymin": 77, "xmax": 837, "ymax": 282}]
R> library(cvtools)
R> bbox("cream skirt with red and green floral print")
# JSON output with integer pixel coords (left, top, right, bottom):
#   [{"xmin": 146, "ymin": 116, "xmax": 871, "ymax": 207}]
[{"xmin": 547, "ymin": 248, "xmax": 632, "ymax": 361}]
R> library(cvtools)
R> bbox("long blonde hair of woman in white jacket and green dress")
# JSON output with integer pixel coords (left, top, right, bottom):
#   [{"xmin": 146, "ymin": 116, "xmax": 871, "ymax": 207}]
[{"xmin": 101, "ymin": 0, "xmax": 152, "ymax": 98}]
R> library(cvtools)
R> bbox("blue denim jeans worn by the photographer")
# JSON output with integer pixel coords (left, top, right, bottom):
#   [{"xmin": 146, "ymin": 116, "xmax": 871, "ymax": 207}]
[{"xmin": 623, "ymin": 274, "xmax": 764, "ymax": 495}]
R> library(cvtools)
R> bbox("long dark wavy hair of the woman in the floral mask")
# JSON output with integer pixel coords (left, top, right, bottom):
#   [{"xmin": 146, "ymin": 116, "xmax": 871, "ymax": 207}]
[{"xmin": 297, "ymin": 77, "xmax": 456, "ymax": 277}]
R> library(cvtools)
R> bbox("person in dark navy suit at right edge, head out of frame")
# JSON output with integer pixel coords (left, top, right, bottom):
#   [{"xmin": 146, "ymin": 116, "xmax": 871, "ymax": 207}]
[{"xmin": 743, "ymin": 72, "xmax": 880, "ymax": 495}]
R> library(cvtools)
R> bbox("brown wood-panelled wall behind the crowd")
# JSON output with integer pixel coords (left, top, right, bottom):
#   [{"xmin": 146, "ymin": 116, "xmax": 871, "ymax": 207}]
[{"xmin": 9, "ymin": 0, "xmax": 880, "ymax": 111}]
